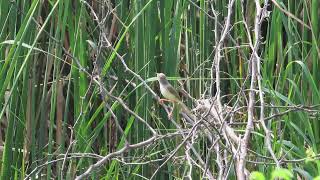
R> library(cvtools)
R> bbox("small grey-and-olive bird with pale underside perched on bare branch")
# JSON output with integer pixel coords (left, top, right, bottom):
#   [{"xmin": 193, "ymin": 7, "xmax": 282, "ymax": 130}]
[{"xmin": 157, "ymin": 73, "xmax": 195, "ymax": 120}]
